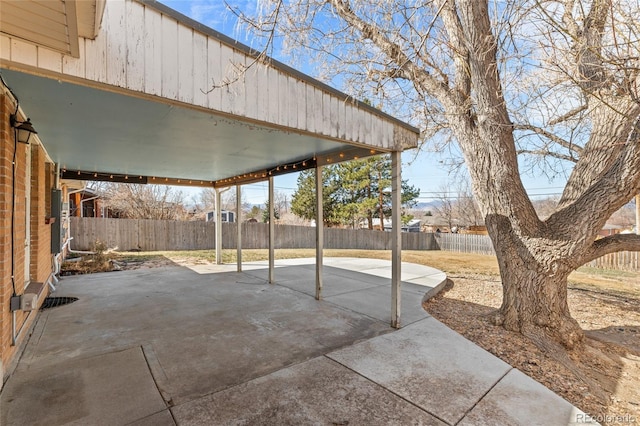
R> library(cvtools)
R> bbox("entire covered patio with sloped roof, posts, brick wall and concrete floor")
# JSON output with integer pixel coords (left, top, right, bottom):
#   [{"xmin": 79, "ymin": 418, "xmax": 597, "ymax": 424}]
[{"xmin": 0, "ymin": 0, "xmax": 596, "ymax": 425}]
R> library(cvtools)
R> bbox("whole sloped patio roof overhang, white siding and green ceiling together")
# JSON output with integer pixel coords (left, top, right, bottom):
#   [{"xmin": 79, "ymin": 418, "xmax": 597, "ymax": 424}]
[{"xmin": 0, "ymin": 0, "xmax": 418, "ymax": 187}]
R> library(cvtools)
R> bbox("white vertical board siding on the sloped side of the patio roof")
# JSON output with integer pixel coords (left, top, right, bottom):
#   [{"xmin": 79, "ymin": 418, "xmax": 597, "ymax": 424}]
[{"xmin": 0, "ymin": 0, "xmax": 416, "ymax": 149}]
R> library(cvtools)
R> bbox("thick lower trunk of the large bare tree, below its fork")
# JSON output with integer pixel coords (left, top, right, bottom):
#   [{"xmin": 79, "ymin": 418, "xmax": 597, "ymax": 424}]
[{"xmin": 487, "ymin": 217, "xmax": 584, "ymax": 349}]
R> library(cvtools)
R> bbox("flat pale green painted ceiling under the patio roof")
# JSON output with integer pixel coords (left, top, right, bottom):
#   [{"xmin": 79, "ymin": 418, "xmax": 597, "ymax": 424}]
[{"xmin": 0, "ymin": 69, "xmax": 364, "ymax": 181}]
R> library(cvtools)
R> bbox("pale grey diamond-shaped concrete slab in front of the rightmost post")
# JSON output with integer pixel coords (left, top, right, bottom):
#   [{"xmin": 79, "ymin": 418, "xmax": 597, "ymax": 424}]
[{"xmin": 327, "ymin": 318, "xmax": 511, "ymax": 424}]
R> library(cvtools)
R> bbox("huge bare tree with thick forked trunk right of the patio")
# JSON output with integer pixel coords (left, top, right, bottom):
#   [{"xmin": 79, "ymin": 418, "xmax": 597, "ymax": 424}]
[{"xmin": 232, "ymin": 0, "xmax": 640, "ymax": 348}]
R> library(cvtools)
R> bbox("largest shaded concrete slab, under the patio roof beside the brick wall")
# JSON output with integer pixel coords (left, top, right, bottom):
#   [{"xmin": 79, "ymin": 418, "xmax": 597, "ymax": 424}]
[{"xmin": 18, "ymin": 267, "xmax": 391, "ymax": 404}]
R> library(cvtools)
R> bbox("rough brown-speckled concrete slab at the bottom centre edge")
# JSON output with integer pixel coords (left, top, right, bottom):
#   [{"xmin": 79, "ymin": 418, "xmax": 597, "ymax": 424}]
[{"xmin": 172, "ymin": 357, "xmax": 445, "ymax": 426}]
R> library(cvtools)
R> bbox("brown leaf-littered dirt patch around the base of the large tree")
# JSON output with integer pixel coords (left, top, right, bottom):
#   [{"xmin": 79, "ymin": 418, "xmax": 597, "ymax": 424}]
[{"xmin": 424, "ymin": 274, "xmax": 640, "ymax": 424}]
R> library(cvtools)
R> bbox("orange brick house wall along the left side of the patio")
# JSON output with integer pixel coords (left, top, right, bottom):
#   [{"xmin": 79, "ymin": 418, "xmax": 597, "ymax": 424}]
[{"xmin": 0, "ymin": 93, "xmax": 52, "ymax": 382}]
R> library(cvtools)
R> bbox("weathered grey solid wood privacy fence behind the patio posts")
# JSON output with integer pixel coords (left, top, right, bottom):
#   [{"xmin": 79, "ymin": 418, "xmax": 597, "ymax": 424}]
[{"xmin": 70, "ymin": 217, "xmax": 438, "ymax": 251}]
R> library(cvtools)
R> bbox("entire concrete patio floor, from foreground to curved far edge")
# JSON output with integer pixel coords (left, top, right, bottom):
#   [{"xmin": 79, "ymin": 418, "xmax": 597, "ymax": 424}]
[{"xmin": 0, "ymin": 258, "xmax": 579, "ymax": 426}]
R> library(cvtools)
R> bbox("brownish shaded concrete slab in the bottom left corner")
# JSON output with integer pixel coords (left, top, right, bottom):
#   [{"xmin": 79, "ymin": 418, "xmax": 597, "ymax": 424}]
[{"xmin": 0, "ymin": 347, "xmax": 166, "ymax": 425}]
